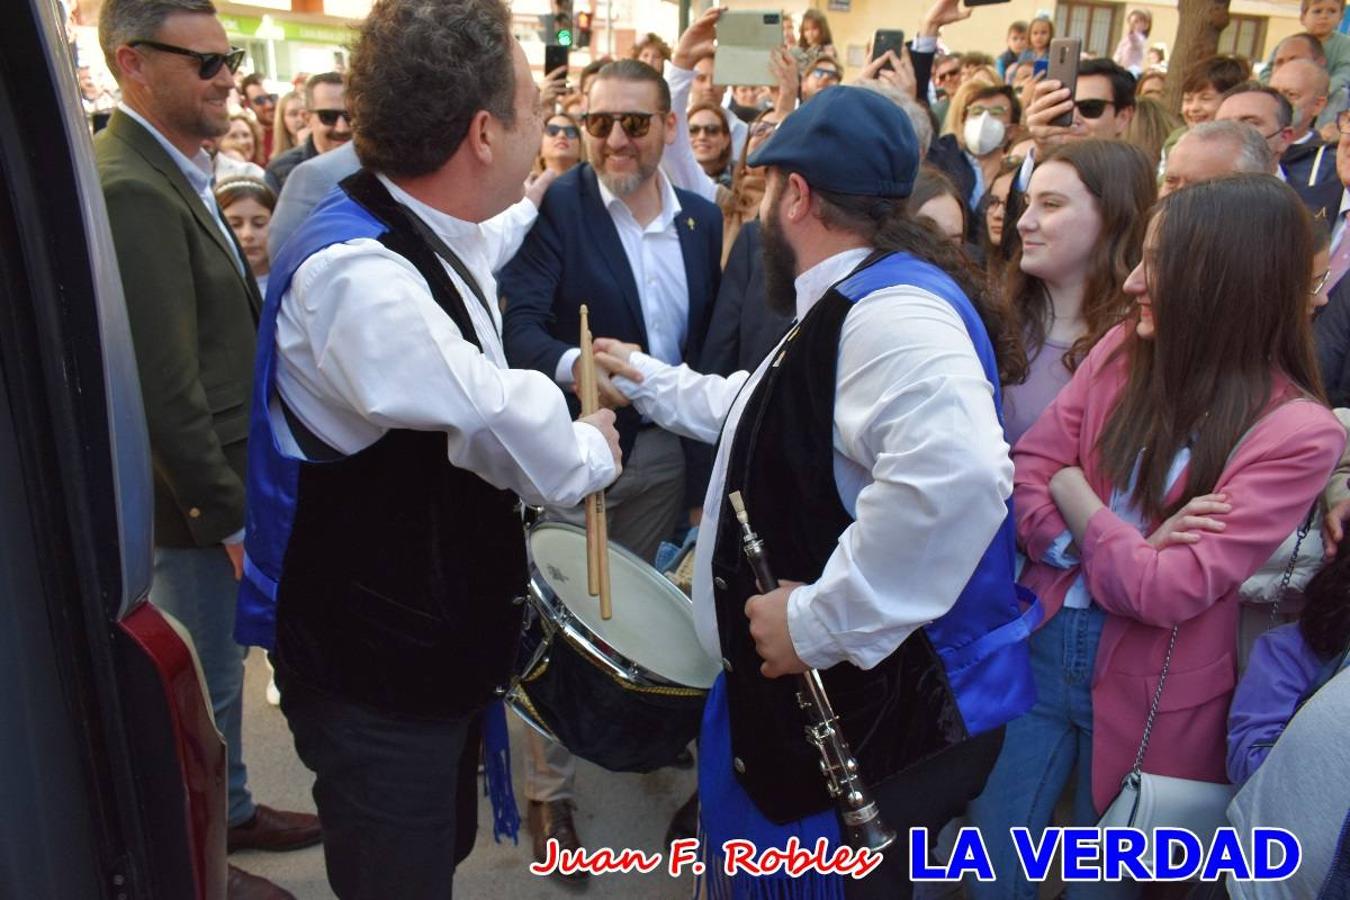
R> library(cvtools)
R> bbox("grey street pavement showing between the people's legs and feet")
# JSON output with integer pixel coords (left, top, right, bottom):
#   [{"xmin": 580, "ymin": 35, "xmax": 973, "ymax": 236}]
[{"xmin": 230, "ymin": 650, "xmax": 695, "ymax": 900}]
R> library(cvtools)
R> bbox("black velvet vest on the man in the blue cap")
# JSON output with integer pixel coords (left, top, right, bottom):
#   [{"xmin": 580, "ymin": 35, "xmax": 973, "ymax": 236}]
[{"xmin": 713, "ymin": 267, "xmax": 968, "ymax": 823}]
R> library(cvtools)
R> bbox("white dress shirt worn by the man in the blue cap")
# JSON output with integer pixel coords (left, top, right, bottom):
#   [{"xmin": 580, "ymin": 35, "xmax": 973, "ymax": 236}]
[{"xmin": 616, "ymin": 248, "xmax": 1013, "ymax": 668}]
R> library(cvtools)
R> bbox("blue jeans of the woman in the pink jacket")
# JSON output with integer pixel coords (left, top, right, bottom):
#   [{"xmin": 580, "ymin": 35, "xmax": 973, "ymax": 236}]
[{"xmin": 965, "ymin": 606, "xmax": 1135, "ymax": 900}]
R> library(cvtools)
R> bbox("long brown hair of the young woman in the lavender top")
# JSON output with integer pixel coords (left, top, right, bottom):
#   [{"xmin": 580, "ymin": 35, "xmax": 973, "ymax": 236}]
[{"xmin": 1003, "ymin": 140, "xmax": 1157, "ymax": 371}]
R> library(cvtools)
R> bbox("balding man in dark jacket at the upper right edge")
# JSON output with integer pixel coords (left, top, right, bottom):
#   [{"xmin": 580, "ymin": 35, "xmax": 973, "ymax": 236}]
[{"xmin": 1270, "ymin": 59, "xmax": 1341, "ymax": 219}]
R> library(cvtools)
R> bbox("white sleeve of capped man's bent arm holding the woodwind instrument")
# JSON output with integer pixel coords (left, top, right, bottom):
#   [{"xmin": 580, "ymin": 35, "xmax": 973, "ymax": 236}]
[{"xmin": 787, "ymin": 286, "xmax": 1013, "ymax": 669}]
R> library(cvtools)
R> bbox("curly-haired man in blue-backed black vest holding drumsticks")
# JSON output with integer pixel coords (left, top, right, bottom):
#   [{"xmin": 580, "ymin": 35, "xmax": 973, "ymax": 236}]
[{"xmin": 238, "ymin": 0, "xmax": 620, "ymax": 900}]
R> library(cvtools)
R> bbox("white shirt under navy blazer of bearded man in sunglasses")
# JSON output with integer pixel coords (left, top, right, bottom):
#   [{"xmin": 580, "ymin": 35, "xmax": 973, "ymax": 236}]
[{"xmin": 553, "ymin": 171, "xmax": 689, "ymax": 386}]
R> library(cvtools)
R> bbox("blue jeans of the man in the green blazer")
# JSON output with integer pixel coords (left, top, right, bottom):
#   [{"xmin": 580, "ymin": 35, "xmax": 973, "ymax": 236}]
[{"xmin": 150, "ymin": 546, "xmax": 254, "ymax": 827}]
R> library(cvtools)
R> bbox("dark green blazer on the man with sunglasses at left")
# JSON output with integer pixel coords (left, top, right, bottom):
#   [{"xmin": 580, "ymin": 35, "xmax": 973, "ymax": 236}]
[{"xmin": 93, "ymin": 111, "xmax": 262, "ymax": 546}]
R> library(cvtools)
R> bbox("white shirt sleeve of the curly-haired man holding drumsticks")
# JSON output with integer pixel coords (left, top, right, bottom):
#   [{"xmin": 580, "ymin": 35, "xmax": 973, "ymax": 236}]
[{"xmin": 285, "ymin": 242, "xmax": 618, "ymax": 506}]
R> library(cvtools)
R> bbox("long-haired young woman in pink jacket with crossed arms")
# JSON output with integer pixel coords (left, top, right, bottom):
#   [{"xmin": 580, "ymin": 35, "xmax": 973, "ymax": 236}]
[{"xmin": 971, "ymin": 175, "xmax": 1346, "ymax": 897}]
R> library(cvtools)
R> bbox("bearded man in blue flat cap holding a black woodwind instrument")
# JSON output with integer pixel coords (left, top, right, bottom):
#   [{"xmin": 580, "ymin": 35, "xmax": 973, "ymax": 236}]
[{"xmin": 595, "ymin": 86, "xmax": 1040, "ymax": 897}]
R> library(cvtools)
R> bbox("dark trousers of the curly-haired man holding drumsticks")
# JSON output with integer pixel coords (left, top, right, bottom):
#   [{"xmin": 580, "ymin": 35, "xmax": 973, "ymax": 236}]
[{"xmin": 277, "ymin": 671, "xmax": 481, "ymax": 900}]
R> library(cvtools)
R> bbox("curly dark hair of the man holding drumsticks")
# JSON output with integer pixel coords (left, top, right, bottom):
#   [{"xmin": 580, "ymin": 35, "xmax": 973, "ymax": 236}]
[{"xmin": 347, "ymin": 0, "xmax": 516, "ymax": 177}]
